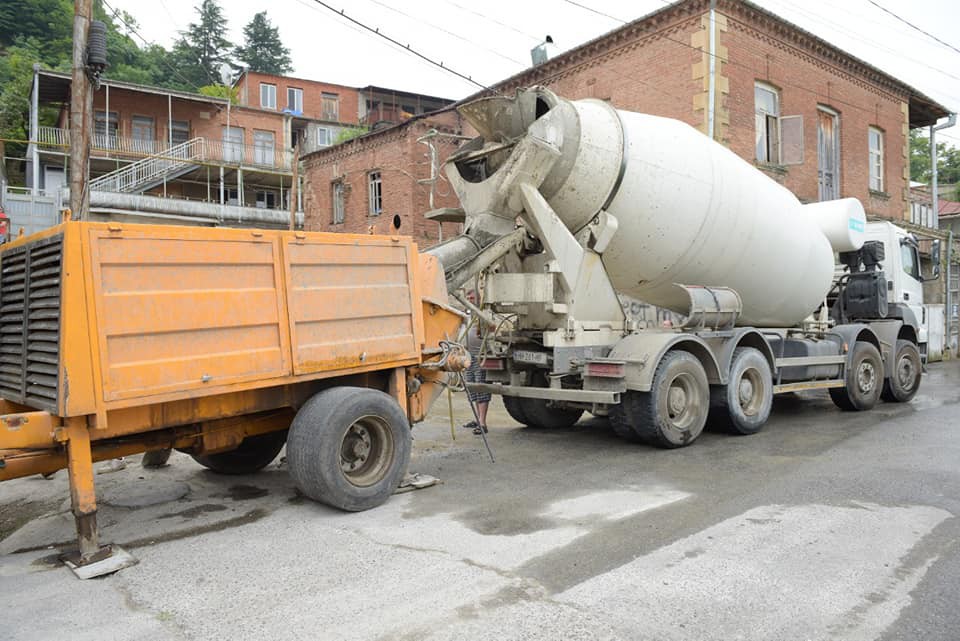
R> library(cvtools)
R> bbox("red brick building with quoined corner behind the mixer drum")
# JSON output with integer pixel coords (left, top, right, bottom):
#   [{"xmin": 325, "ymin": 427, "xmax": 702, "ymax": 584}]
[{"xmin": 305, "ymin": 0, "xmax": 948, "ymax": 245}]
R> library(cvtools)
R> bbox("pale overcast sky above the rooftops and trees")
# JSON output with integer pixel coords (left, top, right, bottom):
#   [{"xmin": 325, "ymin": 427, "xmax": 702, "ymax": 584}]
[{"xmin": 107, "ymin": 0, "xmax": 960, "ymax": 142}]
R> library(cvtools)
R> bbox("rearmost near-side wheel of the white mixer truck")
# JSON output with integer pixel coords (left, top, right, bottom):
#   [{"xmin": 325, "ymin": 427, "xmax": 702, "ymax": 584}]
[{"xmin": 610, "ymin": 351, "xmax": 710, "ymax": 449}]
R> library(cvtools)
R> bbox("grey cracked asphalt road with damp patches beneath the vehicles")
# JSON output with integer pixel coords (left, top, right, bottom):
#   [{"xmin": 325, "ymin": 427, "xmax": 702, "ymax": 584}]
[{"xmin": 0, "ymin": 363, "xmax": 960, "ymax": 641}]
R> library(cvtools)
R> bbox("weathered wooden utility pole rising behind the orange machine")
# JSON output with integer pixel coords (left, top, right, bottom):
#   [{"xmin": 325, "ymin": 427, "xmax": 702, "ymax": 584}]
[{"xmin": 69, "ymin": 0, "xmax": 94, "ymax": 220}]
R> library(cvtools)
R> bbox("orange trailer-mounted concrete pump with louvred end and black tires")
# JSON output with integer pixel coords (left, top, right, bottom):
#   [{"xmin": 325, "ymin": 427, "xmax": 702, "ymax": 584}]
[{"xmin": 0, "ymin": 222, "xmax": 469, "ymax": 566}]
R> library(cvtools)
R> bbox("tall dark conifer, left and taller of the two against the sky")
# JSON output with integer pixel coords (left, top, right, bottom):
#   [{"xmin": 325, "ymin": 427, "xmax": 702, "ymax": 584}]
[{"xmin": 170, "ymin": 0, "xmax": 233, "ymax": 91}]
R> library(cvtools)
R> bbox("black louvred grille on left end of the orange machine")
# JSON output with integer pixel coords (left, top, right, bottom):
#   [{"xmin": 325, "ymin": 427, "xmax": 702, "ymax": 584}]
[{"xmin": 0, "ymin": 235, "xmax": 63, "ymax": 412}]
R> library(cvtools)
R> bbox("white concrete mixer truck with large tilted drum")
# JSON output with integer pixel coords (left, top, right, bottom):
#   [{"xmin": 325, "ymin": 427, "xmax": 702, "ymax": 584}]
[{"xmin": 430, "ymin": 87, "xmax": 939, "ymax": 448}]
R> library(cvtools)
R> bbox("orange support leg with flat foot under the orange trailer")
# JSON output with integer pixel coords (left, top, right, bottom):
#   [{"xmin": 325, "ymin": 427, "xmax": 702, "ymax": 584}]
[{"xmin": 62, "ymin": 416, "xmax": 137, "ymax": 579}]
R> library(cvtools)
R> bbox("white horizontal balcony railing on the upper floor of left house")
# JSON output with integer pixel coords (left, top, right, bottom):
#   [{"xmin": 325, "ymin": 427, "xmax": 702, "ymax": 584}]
[{"xmin": 38, "ymin": 127, "xmax": 293, "ymax": 171}]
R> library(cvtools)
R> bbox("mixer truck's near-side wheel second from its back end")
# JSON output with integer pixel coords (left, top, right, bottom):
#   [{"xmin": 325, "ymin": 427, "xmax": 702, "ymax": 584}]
[{"xmin": 707, "ymin": 347, "xmax": 773, "ymax": 435}]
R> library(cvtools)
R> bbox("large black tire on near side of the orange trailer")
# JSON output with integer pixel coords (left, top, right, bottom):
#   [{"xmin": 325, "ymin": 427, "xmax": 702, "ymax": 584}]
[{"xmin": 287, "ymin": 387, "xmax": 410, "ymax": 512}]
